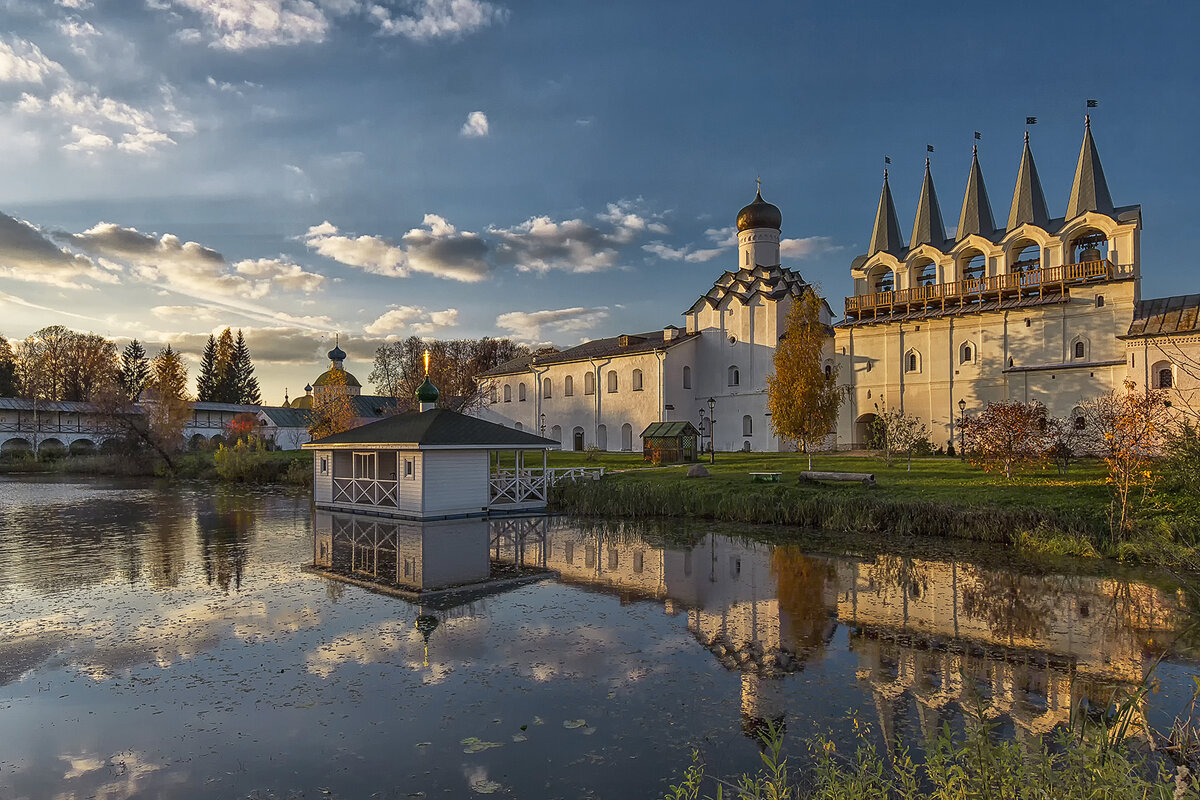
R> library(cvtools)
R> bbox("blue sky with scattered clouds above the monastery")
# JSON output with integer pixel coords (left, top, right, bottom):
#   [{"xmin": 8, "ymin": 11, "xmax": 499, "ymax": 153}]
[{"xmin": 0, "ymin": 0, "xmax": 1200, "ymax": 403}]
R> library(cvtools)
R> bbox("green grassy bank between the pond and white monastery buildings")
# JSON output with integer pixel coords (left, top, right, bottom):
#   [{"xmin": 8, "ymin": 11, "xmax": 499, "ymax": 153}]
[{"xmin": 551, "ymin": 453, "xmax": 1200, "ymax": 561}]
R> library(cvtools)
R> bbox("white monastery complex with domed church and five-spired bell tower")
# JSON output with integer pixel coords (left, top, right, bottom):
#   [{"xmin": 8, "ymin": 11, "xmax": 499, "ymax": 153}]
[{"xmin": 476, "ymin": 119, "xmax": 1200, "ymax": 451}]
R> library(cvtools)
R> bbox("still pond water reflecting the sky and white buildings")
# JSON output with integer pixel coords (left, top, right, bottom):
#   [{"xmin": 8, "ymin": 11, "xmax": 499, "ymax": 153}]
[{"xmin": 0, "ymin": 479, "xmax": 1200, "ymax": 800}]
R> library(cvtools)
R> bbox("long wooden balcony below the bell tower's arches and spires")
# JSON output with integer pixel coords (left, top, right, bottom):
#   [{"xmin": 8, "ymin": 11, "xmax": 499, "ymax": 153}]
[{"xmin": 846, "ymin": 259, "xmax": 1133, "ymax": 320}]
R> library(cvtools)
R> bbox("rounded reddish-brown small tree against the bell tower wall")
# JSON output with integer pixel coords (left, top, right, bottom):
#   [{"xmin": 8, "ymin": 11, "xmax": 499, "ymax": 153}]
[{"xmin": 962, "ymin": 401, "xmax": 1051, "ymax": 479}]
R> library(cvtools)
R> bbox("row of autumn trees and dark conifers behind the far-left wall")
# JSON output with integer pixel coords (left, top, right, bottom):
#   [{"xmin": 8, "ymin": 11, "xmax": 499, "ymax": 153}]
[{"xmin": 0, "ymin": 325, "xmax": 260, "ymax": 405}]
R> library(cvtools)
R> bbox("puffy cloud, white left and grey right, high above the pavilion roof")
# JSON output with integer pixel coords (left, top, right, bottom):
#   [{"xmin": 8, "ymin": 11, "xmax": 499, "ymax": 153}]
[{"xmin": 301, "ymin": 213, "xmax": 491, "ymax": 283}]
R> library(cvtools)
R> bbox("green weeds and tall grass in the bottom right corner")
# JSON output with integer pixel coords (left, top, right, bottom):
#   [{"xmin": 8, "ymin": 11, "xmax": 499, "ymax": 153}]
[{"xmin": 665, "ymin": 714, "xmax": 1200, "ymax": 800}]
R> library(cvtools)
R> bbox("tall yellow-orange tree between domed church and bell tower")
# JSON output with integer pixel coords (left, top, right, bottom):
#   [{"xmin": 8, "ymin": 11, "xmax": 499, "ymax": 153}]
[{"xmin": 767, "ymin": 289, "xmax": 841, "ymax": 469}]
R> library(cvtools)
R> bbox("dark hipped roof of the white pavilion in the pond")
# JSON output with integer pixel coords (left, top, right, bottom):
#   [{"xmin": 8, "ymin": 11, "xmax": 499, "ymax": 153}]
[{"xmin": 304, "ymin": 408, "xmax": 562, "ymax": 450}]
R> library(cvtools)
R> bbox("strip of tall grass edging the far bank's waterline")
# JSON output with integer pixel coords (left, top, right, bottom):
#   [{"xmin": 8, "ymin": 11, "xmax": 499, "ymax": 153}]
[{"xmin": 551, "ymin": 480, "xmax": 1097, "ymax": 542}]
